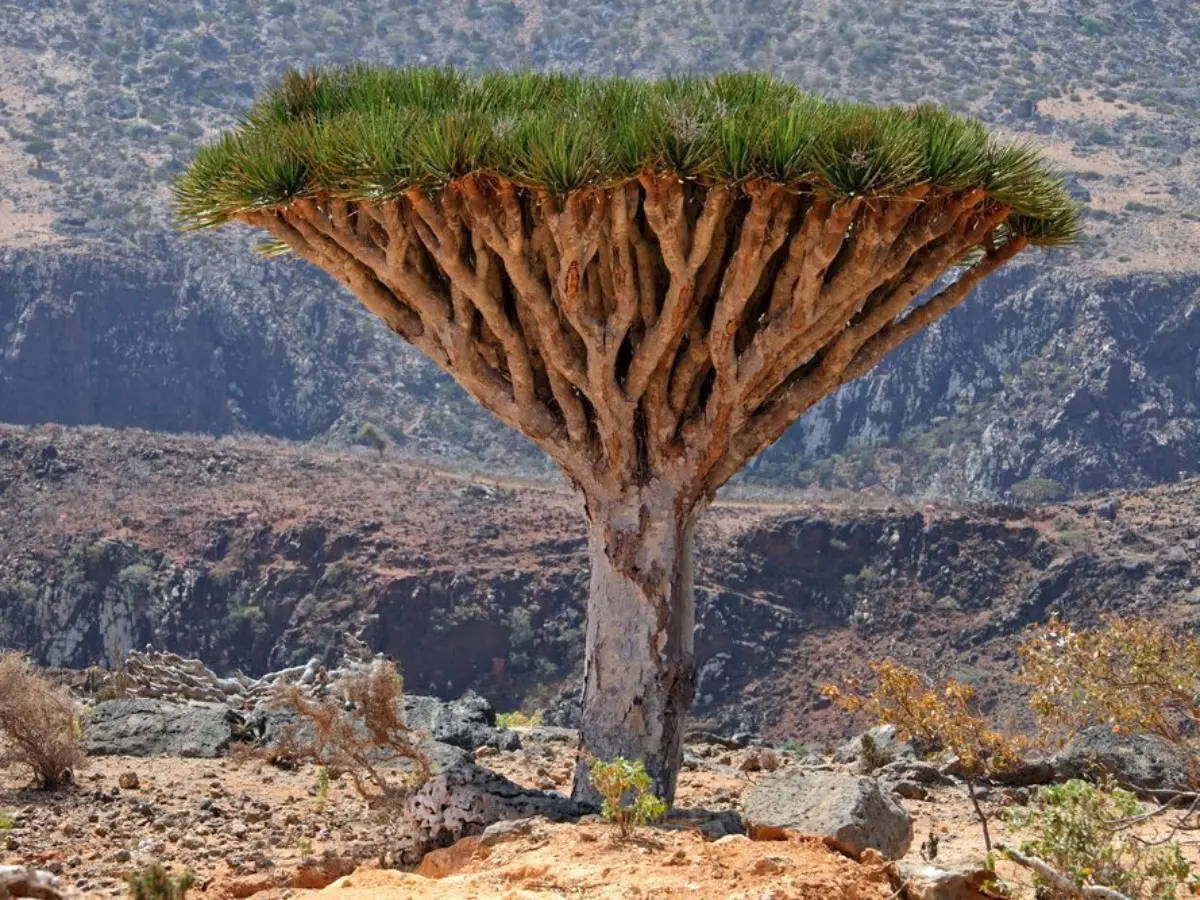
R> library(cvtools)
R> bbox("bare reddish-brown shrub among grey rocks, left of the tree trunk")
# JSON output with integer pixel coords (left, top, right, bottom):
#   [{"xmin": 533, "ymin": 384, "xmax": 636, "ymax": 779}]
[{"xmin": 269, "ymin": 662, "xmax": 432, "ymax": 805}]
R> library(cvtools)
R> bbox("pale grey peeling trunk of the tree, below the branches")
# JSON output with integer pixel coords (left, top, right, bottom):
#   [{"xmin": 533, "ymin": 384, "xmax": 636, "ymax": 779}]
[{"xmin": 572, "ymin": 479, "xmax": 700, "ymax": 805}]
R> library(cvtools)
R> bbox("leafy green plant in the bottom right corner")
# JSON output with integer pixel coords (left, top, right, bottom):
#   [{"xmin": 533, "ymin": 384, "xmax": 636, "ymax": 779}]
[{"xmin": 1009, "ymin": 779, "xmax": 1195, "ymax": 900}]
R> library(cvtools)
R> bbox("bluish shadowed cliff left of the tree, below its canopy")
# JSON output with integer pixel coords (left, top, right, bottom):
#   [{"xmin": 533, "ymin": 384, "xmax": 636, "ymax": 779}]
[{"xmin": 0, "ymin": 235, "xmax": 535, "ymax": 462}]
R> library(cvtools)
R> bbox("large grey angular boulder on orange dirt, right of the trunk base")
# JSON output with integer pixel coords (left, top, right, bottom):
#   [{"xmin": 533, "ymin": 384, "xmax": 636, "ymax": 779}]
[{"xmin": 742, "ymin": 766, "xmax": 912, "ymax": 859}]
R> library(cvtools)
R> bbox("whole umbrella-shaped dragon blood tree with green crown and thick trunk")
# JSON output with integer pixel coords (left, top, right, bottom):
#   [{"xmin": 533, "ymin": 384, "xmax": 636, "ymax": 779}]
[{"xmin": 176, "ymin": 67, "xmax": 1078, "ymax": 802}]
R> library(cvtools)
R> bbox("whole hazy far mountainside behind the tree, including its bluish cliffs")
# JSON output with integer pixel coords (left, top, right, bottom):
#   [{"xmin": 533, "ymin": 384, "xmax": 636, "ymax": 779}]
[{"xmin": 0, "ymin": 0, "xmax": 1200, "ymax": 498}]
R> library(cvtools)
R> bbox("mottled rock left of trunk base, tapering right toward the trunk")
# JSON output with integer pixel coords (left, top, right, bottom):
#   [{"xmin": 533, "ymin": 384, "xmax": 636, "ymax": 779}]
[{"xmin": 397, "ymin": 760, "xmax": 595, "ymax": 864}]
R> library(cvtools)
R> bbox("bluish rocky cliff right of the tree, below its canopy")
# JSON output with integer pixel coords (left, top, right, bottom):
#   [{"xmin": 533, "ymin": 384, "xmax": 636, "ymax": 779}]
[{"xmin": 757, "ymin": 266, "xmax": 1200, "ymax": 499}]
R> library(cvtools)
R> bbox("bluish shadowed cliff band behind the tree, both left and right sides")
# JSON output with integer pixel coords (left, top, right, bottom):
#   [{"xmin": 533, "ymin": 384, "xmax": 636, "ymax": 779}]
[{"xmin": 0, "ymin": 238, "xmax": 1200, "ymax": 499}]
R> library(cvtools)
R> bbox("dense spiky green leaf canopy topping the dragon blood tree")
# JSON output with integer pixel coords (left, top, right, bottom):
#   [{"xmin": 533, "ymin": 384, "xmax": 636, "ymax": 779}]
[{"xmin": 176, "ymin": 65, "xmax": 1079, "ymax": 246}]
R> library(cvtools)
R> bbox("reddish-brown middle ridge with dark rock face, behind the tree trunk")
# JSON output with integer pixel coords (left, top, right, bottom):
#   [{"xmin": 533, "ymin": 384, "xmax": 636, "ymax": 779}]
[{"xmin": 0, "ymin": 427, "xmax": 1200, "ymax": 743}]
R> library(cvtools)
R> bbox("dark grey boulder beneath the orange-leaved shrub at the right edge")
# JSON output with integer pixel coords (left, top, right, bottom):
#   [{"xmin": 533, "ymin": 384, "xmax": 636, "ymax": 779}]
[{"xmin": 1051, "ymin": 726, "xmax": 1189, "ymax": 791}]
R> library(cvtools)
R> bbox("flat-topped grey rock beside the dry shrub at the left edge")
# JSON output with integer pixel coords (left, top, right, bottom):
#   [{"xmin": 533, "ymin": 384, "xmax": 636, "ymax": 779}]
[{"xmin": 83, "ymin": 698, "xmax": 241, "ymax": 760}]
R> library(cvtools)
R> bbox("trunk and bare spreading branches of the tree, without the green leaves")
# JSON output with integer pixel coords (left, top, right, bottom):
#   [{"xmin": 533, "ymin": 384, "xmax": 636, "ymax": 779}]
[{"xmin": 234, "ymin": 173, "xmax": 1026, "ymax": 800}]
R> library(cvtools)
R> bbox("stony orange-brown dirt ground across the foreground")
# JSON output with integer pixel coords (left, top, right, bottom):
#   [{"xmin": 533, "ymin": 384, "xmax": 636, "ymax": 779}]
[{"xmin": 9, "ymin": 740, "xmax": 1200, "ymax": 900}]
